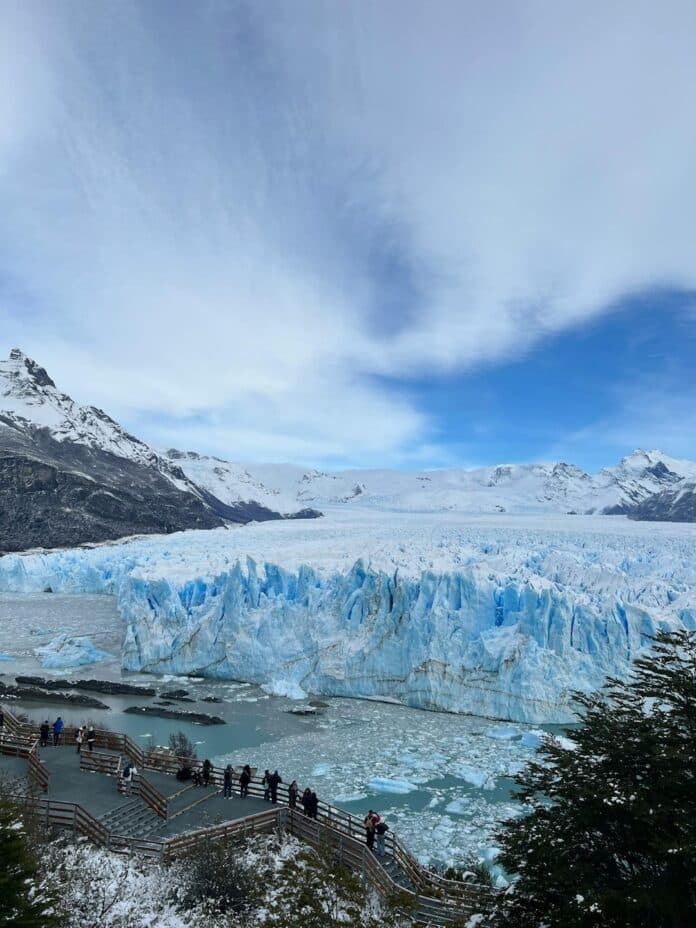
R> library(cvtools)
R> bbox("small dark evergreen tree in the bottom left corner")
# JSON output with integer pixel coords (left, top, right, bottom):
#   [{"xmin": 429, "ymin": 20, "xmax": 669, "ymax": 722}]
[{"xmin": 0, "ymin": 801, "xmax": 60, "ymax": 928}]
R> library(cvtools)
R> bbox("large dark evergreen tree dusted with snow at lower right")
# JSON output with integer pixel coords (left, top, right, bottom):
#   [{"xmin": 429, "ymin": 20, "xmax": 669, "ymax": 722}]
[{"xmin": 492, "ymin": 631, "xmax": 696, "ymax": 928}]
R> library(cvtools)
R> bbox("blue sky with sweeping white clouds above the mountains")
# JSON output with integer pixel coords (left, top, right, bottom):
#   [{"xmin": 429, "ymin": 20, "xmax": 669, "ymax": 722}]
[{"xmin": 0, "ymin": 0, "xmax": 696, "ymax": 470}]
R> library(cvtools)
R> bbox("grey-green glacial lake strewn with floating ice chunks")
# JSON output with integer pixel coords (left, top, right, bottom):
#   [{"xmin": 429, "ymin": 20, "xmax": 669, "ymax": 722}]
[{"xmin": 0, "ymin": 593, "xmax": 552, "ymax": 864}]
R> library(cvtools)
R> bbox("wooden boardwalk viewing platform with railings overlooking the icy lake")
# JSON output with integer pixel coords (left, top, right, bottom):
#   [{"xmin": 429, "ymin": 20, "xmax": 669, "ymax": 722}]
[{"xmin": 0, "ymin": 707, "xmax": 491, "ymax": 925}]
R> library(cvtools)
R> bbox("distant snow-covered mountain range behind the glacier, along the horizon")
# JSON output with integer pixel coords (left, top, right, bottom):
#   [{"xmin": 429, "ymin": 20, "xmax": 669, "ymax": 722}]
[{"xmin": 166, "ymin": 450, "xmax": 696, "ymax": 521}]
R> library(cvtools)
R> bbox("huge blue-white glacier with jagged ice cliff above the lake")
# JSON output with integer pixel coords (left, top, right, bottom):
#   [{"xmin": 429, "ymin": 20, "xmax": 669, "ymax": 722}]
[{"xmin": 0, "ymin": 511, "xmax": 696, "ymax": 723}]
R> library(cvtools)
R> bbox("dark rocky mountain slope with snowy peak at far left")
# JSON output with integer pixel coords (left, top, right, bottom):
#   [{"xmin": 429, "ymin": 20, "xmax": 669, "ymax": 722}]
[{"xmin": 0, "ymin": 349, "xmax": 316, "ymax": 551}]
